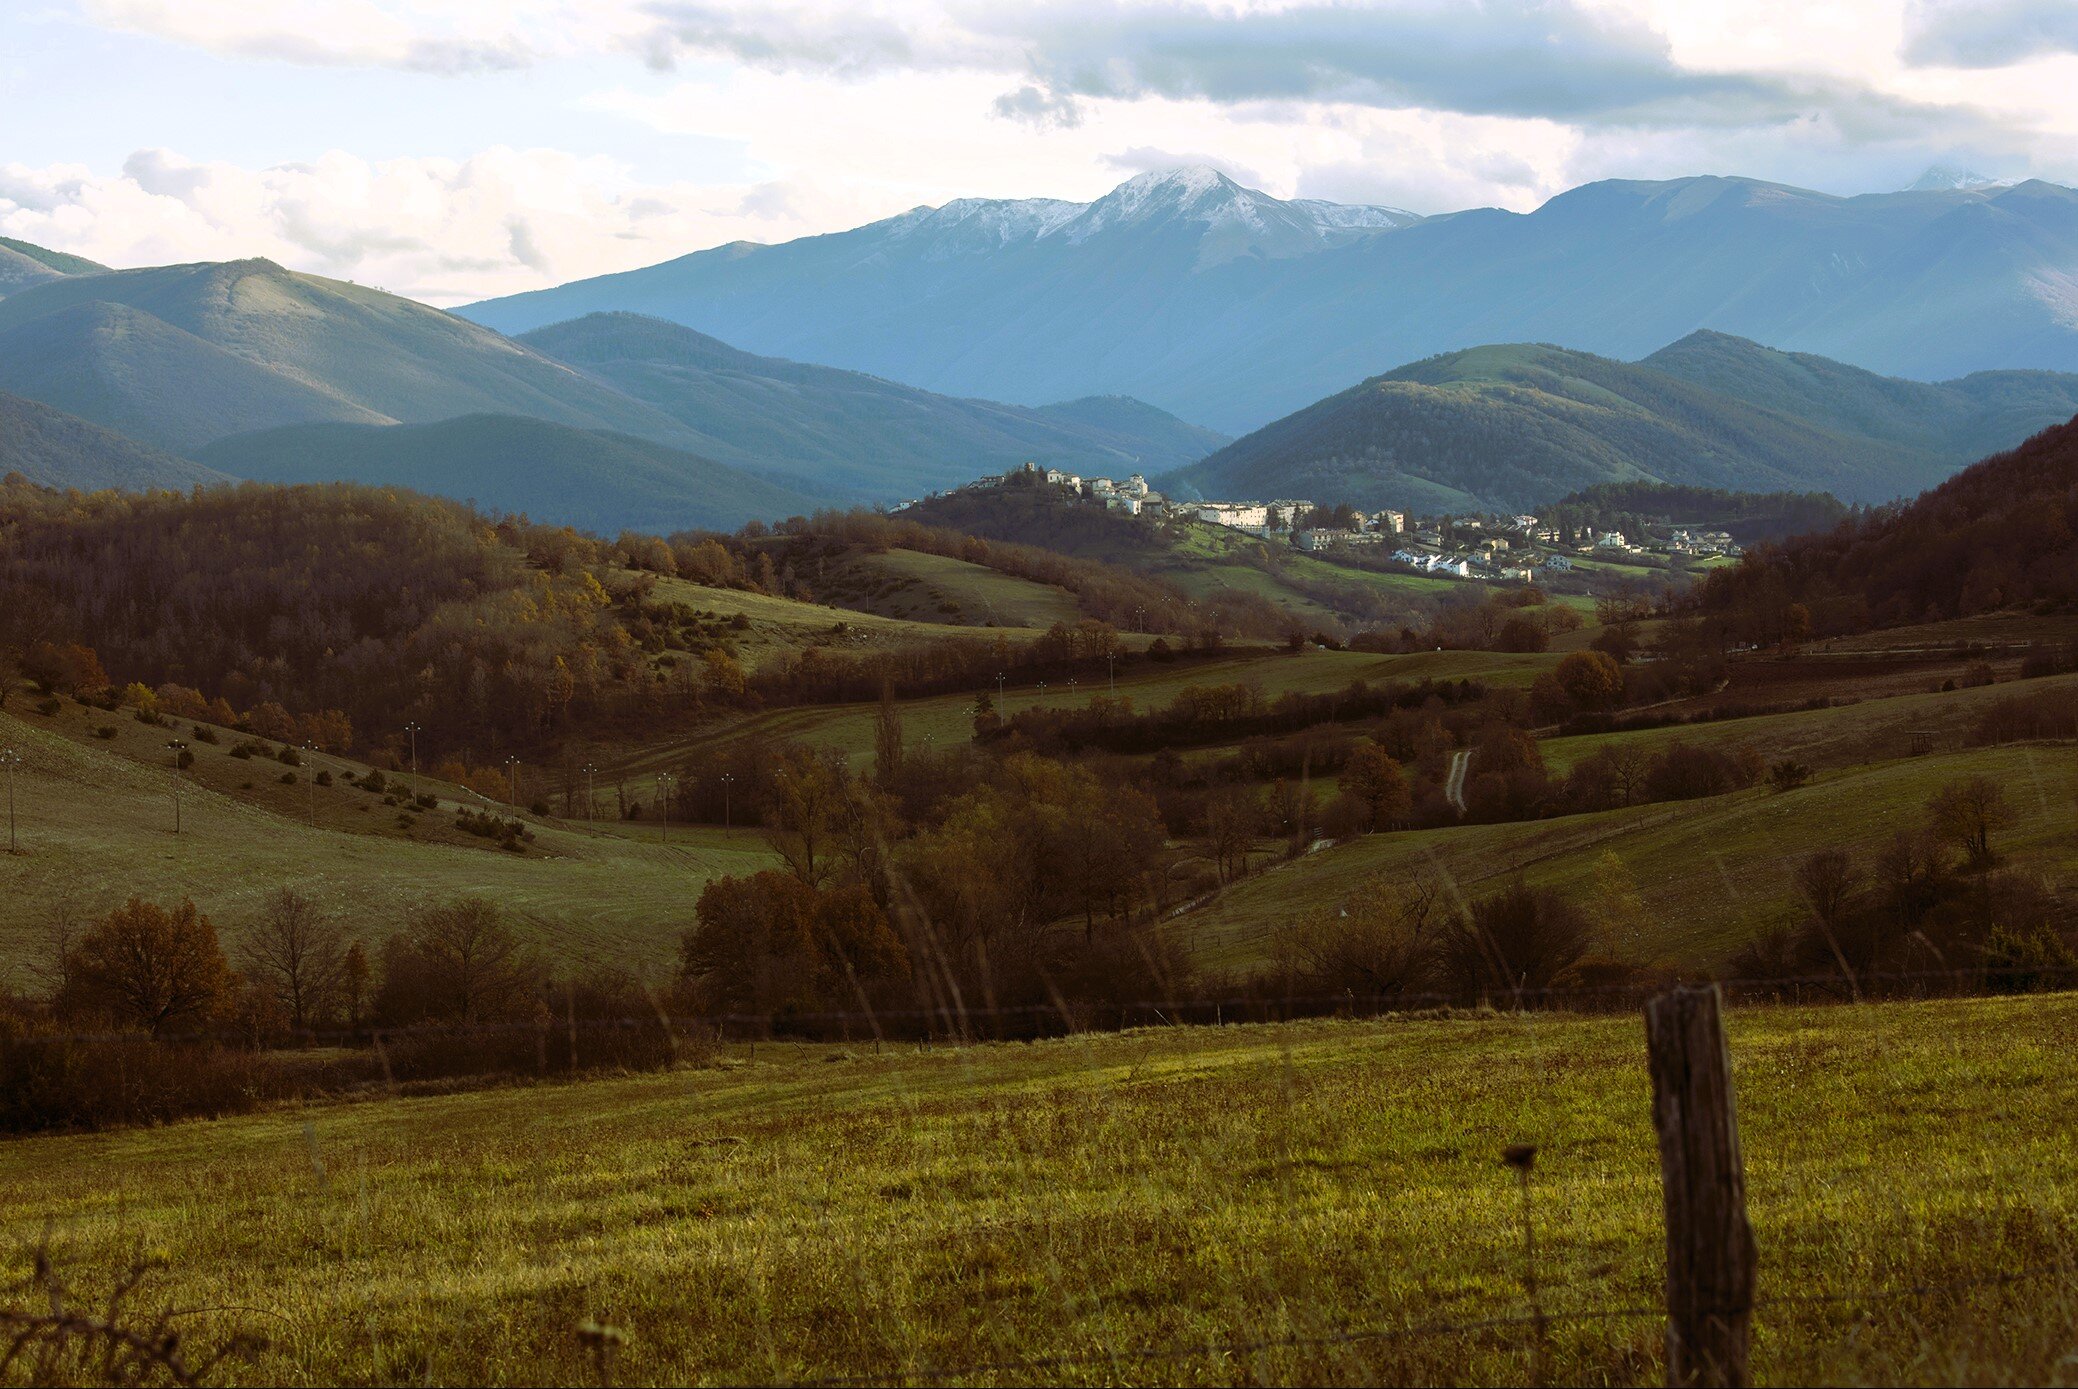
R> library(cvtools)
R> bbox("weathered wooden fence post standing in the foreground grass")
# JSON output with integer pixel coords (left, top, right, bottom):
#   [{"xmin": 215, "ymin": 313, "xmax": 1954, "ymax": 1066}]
[{"xmin": 1646, "ymin": 984, "xmax": 1754, "ymax": 1387}]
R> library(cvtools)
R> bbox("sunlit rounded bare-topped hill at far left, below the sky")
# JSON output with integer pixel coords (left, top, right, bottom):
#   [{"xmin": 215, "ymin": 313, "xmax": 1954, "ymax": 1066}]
[{"xmin": 0, "ymin": 260, "xmax": 702, "ymax": 447}]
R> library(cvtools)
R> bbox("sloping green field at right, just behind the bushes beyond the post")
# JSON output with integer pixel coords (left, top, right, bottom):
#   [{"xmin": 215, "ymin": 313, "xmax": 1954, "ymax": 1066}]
[{"xmin": 1174, "ymin": 744, "xmax": 2078, "ymax": 969}]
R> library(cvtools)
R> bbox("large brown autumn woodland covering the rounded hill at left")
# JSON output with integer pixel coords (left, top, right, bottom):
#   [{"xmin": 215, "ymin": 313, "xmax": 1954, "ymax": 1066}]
[{"xmin": 0, "ymin": 480, "xmax": 652, "ymax": 749}]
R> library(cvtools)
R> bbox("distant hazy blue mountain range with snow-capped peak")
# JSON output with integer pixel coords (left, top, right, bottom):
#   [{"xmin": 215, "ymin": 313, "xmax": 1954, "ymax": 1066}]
[{"xmin": 459, "ymin": 168, "xmax": 2078, "ymax": 435}]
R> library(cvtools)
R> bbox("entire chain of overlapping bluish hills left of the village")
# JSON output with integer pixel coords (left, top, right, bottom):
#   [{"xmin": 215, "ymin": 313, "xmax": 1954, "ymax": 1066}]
[{"xmin": 0, "ymin": 243, "xmax": 1226, "ymax": 513}]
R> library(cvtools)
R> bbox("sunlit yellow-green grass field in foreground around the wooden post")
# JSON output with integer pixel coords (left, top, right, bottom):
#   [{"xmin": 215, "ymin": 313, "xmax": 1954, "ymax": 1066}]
[{"xmin": 0, "ymin": 996, "xmax": 2078, "ymax": 1385}]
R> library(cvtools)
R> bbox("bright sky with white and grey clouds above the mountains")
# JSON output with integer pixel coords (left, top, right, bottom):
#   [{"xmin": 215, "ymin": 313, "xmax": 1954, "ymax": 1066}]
[{"xmin": 0, "ymin": 0, "xmax": 2078, "ymax": 306}]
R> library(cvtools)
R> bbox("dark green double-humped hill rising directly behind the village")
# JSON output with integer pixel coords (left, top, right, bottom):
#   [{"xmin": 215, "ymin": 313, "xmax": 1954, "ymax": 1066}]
[{"xmin": 1164, "ymin": 333, "xmax": 2078, "ymax": 512}]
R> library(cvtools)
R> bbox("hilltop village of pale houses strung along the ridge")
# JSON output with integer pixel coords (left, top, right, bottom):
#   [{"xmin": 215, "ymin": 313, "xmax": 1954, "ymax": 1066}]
[{"xmin": 891, "ymin": 464, "xmax": 1741, "ymax": 582}]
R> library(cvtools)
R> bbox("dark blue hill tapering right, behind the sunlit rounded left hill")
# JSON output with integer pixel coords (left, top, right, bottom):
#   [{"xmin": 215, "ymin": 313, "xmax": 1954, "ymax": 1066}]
[{"xmin": 520, "ymin": 314, "xmax": 1226, "ymax": 499}]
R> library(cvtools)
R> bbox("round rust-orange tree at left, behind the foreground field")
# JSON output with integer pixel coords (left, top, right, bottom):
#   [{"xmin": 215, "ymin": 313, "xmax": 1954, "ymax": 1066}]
[{"xmin": 60, "ymin": 896, "xmax": 231, "ymax": 1038}]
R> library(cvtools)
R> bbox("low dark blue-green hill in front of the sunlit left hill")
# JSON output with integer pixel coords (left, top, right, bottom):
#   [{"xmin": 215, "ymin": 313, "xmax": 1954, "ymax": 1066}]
[{"xmin": 195, "ymin": 414, "xmax": 815, "ymax": 534}]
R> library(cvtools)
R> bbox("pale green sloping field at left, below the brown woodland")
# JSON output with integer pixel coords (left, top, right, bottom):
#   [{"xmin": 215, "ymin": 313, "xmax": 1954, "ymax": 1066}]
[{"xmin": 0, "ymin": 705, "xmax": 775, "ymax": 975}]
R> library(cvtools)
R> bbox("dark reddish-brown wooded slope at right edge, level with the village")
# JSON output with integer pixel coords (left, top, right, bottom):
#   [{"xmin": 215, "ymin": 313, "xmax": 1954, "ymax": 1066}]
[{"xmin": 1691, "ymin": 415, "xmax": 2078, "ymax": 643}]
